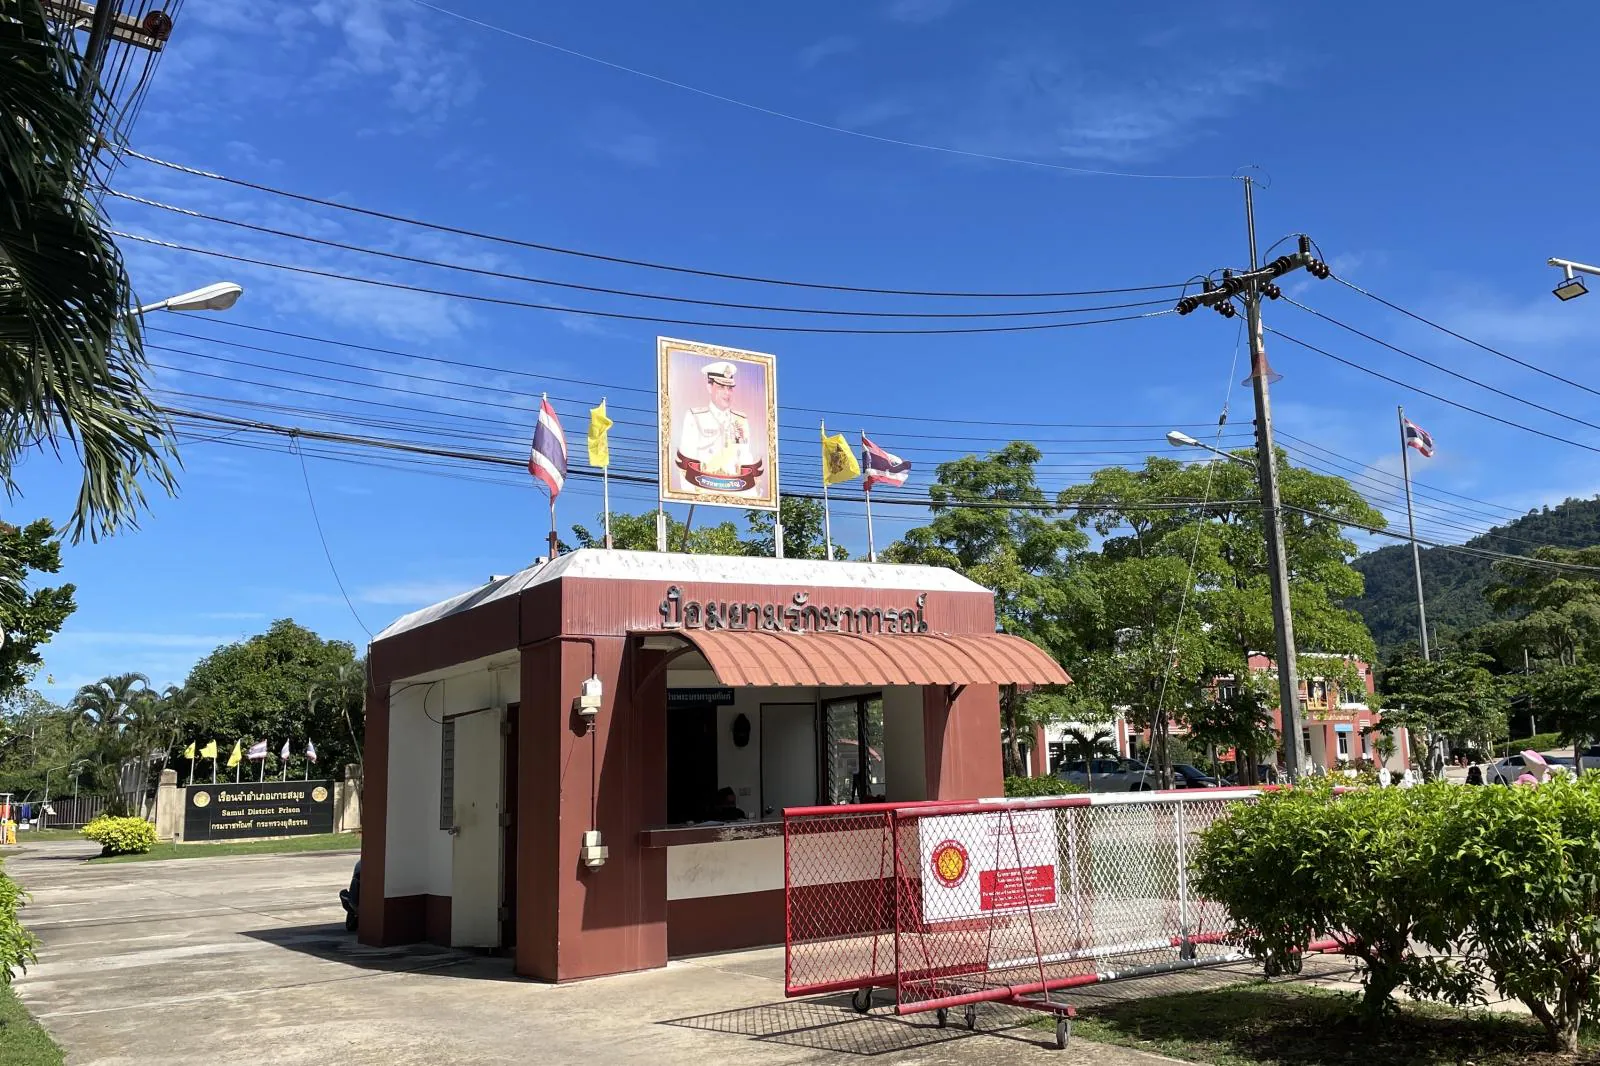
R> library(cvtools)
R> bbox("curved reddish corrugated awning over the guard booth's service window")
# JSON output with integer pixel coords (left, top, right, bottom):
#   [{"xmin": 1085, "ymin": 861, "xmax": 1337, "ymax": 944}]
[{"xmin": 651, "ymin": 629, "xmax": 1070, "ymax": 687}]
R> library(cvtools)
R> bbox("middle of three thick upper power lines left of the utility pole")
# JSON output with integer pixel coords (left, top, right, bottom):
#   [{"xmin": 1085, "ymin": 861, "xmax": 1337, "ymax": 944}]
[{"xmin": 110, "ymin": 189, "xmax": 1171, "ymax": 319}]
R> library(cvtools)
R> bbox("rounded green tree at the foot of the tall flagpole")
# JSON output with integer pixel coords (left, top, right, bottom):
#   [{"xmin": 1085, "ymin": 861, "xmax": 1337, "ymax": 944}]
[{"xmin": 1379, "ymin": 650, "xmax": 1507, "ymax": 781}]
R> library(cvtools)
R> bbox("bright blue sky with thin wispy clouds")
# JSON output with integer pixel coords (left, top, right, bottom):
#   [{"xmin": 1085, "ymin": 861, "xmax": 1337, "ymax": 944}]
[{"xmin": 11, "ymin": 0, "xmax": 1600, "ymax": 698}]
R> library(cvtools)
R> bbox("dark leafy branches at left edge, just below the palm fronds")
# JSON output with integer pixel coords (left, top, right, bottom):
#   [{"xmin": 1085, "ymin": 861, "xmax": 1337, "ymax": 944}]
[{"xmin": 0, "ymin": 519, "xmax": 77, "ymax": 696}]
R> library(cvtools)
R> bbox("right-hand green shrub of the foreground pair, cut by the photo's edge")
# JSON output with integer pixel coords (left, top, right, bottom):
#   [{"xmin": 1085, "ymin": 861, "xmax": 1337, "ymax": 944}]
[{"xmin": 1427, "ymin": 775, "xmax": 1600, "ymax": 1053}]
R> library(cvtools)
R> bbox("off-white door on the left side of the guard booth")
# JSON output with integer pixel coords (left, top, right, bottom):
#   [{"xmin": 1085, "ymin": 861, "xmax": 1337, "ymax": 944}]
[{"xmin": 450, "ymin": 709, "xmax": 504, "ymax": 948}]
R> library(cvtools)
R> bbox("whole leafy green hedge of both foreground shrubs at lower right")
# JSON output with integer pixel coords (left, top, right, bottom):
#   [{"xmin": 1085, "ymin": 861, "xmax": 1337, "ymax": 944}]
[{"xmin": 1195, "ymin": 775, "xmax": 1600, "ymax": 1052}]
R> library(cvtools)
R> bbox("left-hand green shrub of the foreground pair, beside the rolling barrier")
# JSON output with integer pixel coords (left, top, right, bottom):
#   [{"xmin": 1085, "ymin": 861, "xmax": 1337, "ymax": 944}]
[{"xmin": 1195, "ymin": 783, "xmax": 1475, "ymax": 1021}]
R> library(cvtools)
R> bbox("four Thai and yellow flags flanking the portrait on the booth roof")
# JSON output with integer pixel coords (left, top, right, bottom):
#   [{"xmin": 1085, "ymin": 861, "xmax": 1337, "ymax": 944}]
[{"xmin": 528, "ymin": 395, "xmax": 910, "ymax": 562}]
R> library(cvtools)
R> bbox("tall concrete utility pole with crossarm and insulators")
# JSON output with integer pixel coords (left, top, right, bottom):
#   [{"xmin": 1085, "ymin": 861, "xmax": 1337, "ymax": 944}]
[{"xmin": 1178, "ymin": 178, "xmax": 1330, "ymax": 781}]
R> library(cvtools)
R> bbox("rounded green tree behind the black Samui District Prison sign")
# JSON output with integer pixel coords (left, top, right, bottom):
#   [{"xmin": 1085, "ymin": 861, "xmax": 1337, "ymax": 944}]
[{"xmin": 184, "ymin": 618, "xmax": 365, "ymax": 773}]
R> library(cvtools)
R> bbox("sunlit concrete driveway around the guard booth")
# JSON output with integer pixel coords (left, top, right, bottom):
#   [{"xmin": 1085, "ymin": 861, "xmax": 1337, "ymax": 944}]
[{"xmin": 5, "ymin": 842, "xmax": 1196, "ymax": 1066}]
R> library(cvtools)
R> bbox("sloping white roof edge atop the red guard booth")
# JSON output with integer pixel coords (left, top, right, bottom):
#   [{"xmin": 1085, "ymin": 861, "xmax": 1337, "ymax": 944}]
[{"xmin": 373, "ymin": 547, "xmax": 989, "ymax": 642}]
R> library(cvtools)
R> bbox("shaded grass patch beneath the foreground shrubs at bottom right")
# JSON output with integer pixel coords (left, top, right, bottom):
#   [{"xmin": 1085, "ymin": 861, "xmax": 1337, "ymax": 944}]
[{"xmin": 1072, "ymin": 984, "xmax": 1600, "ymax": 1066}]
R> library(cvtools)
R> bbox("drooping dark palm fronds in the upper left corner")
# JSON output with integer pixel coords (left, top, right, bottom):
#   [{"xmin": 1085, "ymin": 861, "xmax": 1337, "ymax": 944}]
[{"xmin": 0, "ymin": 0, "xmax": 176, "ymax": 541}]
